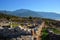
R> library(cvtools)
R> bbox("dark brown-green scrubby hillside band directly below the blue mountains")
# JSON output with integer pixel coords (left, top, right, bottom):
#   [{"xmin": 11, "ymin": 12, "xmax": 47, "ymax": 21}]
[{"xmin": 0, "ymin": 13, "xmax": 60, "ymax": 27}]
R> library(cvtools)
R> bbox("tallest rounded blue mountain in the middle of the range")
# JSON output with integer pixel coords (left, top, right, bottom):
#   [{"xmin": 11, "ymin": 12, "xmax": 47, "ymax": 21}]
[{"xmin": 13, "ymin": 9, "xmax": 40, "ymax": 17}]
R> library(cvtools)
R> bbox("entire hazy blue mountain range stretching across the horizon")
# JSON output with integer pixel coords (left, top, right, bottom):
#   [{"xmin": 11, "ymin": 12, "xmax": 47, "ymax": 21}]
[{"xmin": 0, "ymin": 9, "xmax": 60, "ymax": 20}]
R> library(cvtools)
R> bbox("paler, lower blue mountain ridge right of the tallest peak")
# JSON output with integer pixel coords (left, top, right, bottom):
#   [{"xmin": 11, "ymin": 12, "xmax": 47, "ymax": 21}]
[{"xmin": 39, "ymin": 12, "xmax": 60, "ymax": 20}]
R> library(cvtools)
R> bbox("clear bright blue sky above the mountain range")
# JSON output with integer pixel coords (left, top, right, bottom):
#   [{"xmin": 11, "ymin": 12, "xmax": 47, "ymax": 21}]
[{"xmin": 0, "ymin": 0, "xmax": 60, "ymax": 13}]
